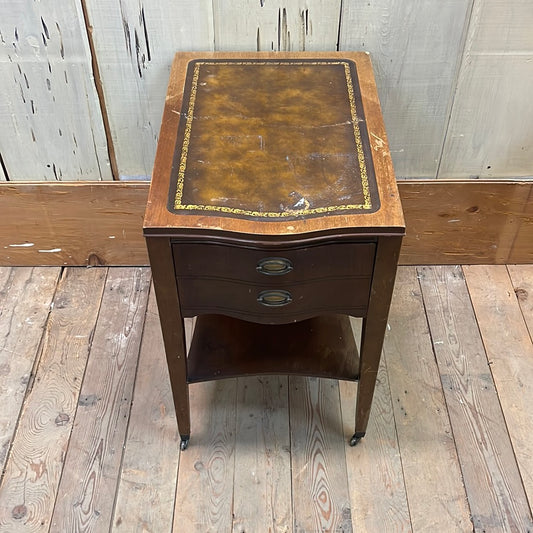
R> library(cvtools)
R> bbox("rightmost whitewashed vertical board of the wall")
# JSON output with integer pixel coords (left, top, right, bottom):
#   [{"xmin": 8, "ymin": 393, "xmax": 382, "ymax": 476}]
[{"xmin": 438, "ymin": 0, "xmax": 533, "ymax": 178}]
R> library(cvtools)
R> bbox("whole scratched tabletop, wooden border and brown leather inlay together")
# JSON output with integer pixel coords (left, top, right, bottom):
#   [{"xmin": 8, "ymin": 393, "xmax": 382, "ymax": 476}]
[{"xmin": 144, "ymin": 52, "xmax": 405, "ymax": 238}]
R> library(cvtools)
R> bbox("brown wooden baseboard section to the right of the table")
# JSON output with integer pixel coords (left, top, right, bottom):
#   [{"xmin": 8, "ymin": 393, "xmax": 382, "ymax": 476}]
[{"xmin": 398, "ymin": 180, "xmax": 533, "ymax": 265}]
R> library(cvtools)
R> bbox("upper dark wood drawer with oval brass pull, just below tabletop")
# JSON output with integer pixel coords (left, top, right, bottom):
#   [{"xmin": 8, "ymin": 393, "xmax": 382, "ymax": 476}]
[{"xmin": 173, "ymin": 243, "xmax": 376, "ymax": 285}]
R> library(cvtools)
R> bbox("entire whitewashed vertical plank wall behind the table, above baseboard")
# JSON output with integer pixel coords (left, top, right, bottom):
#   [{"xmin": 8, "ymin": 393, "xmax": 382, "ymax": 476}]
[{"xmin": 0, "ymin": 0, "xmax": 533, "ymax": 181}]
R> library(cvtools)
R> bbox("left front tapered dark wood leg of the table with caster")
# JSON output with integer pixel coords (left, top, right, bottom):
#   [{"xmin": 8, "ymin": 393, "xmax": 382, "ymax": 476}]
[{"xmin": 146, "ymin": 236, "xmax": 191, "ymax": 450}]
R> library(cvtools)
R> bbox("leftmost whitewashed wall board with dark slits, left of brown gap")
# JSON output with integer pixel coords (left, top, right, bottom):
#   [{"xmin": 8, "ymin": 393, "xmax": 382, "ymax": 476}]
[{"xmin": 0, "ymin": 0, "xmax": 111, "ymax": 181}]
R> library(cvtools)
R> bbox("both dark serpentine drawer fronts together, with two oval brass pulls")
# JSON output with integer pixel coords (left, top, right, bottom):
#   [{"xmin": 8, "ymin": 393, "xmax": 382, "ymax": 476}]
[{"xmin": 173, "ymin": 242, "xmax": 376, "ymax": 324}]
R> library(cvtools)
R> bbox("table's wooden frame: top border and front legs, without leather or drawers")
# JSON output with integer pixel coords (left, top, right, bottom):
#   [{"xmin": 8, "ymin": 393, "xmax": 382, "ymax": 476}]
[{"xmin": 144, "ymin": 52, "xmax": 405, "ymax": 449}]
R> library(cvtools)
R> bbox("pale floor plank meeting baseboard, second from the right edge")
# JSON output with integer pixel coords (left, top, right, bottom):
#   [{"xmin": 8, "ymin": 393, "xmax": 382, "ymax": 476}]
[{"xmin": 463, "ymin": 265, "xmax": 533, "ymax": 512}]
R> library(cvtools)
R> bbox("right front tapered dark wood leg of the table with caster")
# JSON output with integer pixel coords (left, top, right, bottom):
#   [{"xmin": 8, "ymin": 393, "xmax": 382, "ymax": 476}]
[{"xmin": 350, "ymin": 237, "xmax": 402, "ymax": 446}]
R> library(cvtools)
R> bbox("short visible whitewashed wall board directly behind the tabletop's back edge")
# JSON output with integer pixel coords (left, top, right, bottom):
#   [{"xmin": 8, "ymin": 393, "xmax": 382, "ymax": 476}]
[{"xmin": 213, "ymin": 0, "xmax": 341, "ymax": 52}]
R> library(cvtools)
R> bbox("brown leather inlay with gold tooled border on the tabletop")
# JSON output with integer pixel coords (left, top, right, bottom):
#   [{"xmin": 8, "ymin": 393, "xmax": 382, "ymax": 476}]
[{"xmin": 169, "ymin": 60, "xmax": 379, "ymax": 219}]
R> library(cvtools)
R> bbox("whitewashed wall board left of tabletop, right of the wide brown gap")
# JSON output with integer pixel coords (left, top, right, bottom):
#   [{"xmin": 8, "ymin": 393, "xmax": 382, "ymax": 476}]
[{"xmin": 86, "ymin": 0, "xmax": 213, "ymax": 178}]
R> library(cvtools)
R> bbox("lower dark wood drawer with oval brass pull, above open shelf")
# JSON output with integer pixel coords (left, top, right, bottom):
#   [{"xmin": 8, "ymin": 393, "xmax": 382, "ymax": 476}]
[{"xmin": 178, "ymin": 277, "xmax": 370, "ymax": 324}]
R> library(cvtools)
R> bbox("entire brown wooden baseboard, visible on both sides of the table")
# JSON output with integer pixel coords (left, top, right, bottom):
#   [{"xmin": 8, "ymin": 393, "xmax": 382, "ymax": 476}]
[{"xmin": 0, "ymin": 180, "xmax": 533, "ymax": 266}]
